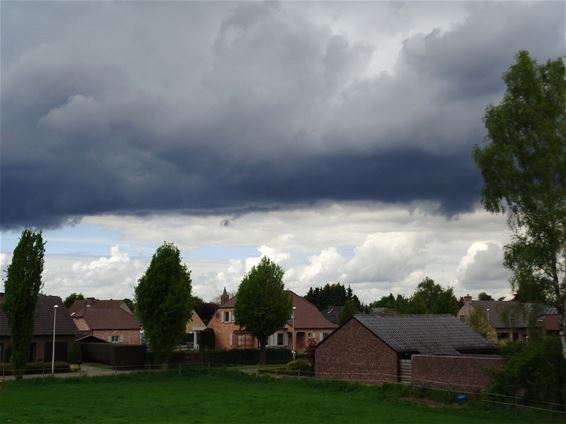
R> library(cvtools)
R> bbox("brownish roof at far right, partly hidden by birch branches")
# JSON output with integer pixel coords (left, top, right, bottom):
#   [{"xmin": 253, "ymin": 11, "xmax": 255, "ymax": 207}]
[{"xmin": 472, "ymin": 300, "xmax": 558, "ymax": 328}]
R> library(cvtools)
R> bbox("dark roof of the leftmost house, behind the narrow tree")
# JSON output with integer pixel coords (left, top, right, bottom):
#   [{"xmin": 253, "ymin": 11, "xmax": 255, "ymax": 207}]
[{"xmin": 0, "ymin": 293, "xmax": 79, "ymax": 337}]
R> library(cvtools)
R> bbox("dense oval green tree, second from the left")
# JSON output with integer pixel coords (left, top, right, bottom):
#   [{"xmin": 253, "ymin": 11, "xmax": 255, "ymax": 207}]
[{"xmin": 135, "ymin": 243, "xmax": 192, "ymax": 363}]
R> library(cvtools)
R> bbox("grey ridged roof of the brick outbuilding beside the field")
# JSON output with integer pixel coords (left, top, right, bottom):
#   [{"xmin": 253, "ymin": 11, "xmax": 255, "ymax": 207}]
[{"xmin": 353, "ymin": 314, "xmax": 495, "ymax": 355}]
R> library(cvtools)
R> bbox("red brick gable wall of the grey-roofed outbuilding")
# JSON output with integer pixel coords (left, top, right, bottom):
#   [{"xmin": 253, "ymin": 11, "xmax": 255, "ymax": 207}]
[{"xmin": 315, "ymin": 319, "xmax": 398, "ymax": 383}]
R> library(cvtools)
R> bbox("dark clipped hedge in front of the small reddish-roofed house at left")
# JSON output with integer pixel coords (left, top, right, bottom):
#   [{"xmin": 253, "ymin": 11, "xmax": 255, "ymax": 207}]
[{"xmin": 81, "ymin": 343, "xmax": 147, "ymax": 367}]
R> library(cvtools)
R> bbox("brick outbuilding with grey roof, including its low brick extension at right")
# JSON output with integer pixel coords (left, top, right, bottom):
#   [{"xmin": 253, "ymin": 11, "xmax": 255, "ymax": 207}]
[{"xmin": 314, "ymin": 314, "xmax": 503, "ymax": 390}]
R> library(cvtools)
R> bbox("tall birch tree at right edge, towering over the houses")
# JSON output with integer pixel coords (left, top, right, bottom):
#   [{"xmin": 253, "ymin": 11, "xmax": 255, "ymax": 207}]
[{"xmin": 473, "ymin": 51, "xmax": 566, "ymax": 358}]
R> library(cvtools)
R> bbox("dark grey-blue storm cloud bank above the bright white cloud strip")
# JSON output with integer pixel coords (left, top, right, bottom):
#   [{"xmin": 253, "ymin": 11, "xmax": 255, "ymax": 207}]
[{"xmin": 0, "ymin": 3, "xmax": 564, "ymax": 228}]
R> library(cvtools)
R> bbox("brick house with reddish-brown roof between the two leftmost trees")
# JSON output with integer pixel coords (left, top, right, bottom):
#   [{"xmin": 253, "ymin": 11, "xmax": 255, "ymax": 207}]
[{"xmin": 69, "ymin": 297, "xmax": 141, "ymax": 344}]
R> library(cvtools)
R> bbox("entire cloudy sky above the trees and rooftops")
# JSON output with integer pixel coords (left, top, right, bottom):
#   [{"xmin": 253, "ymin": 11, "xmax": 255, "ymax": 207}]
[{"xmin": 0, "ymin": 1, "xmax": 566, "ymax": 302}]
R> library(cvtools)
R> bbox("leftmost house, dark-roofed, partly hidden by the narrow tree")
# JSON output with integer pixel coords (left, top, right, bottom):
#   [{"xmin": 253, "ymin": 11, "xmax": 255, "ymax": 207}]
[{"xmin": 0, "ymin": 293, "xmax": 79, "ymax": 362}]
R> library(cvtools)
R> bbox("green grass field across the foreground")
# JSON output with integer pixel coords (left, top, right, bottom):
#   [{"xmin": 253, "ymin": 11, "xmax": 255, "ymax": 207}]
[{"xmin": 0, "ymin": 371, "xmax": 558, "ymax": 424}]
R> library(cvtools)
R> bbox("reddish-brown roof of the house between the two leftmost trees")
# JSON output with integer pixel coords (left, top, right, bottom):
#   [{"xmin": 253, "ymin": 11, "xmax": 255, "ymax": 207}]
[{"xmin": 69, "ymin": 299, "xmax": 141, "ymax": 330}]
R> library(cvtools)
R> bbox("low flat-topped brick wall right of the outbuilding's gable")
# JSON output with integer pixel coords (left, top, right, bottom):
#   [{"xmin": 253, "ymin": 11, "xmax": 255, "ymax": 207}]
[{"xmin": 412, "ymin": 355, "xmax": 505, "ymax": 391}]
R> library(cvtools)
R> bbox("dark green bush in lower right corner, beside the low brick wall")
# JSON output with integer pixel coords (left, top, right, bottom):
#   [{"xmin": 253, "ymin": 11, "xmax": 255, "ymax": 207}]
[{"xmin": 492, "ymin": 337, "xmax": 566, "ymax": 403}]
